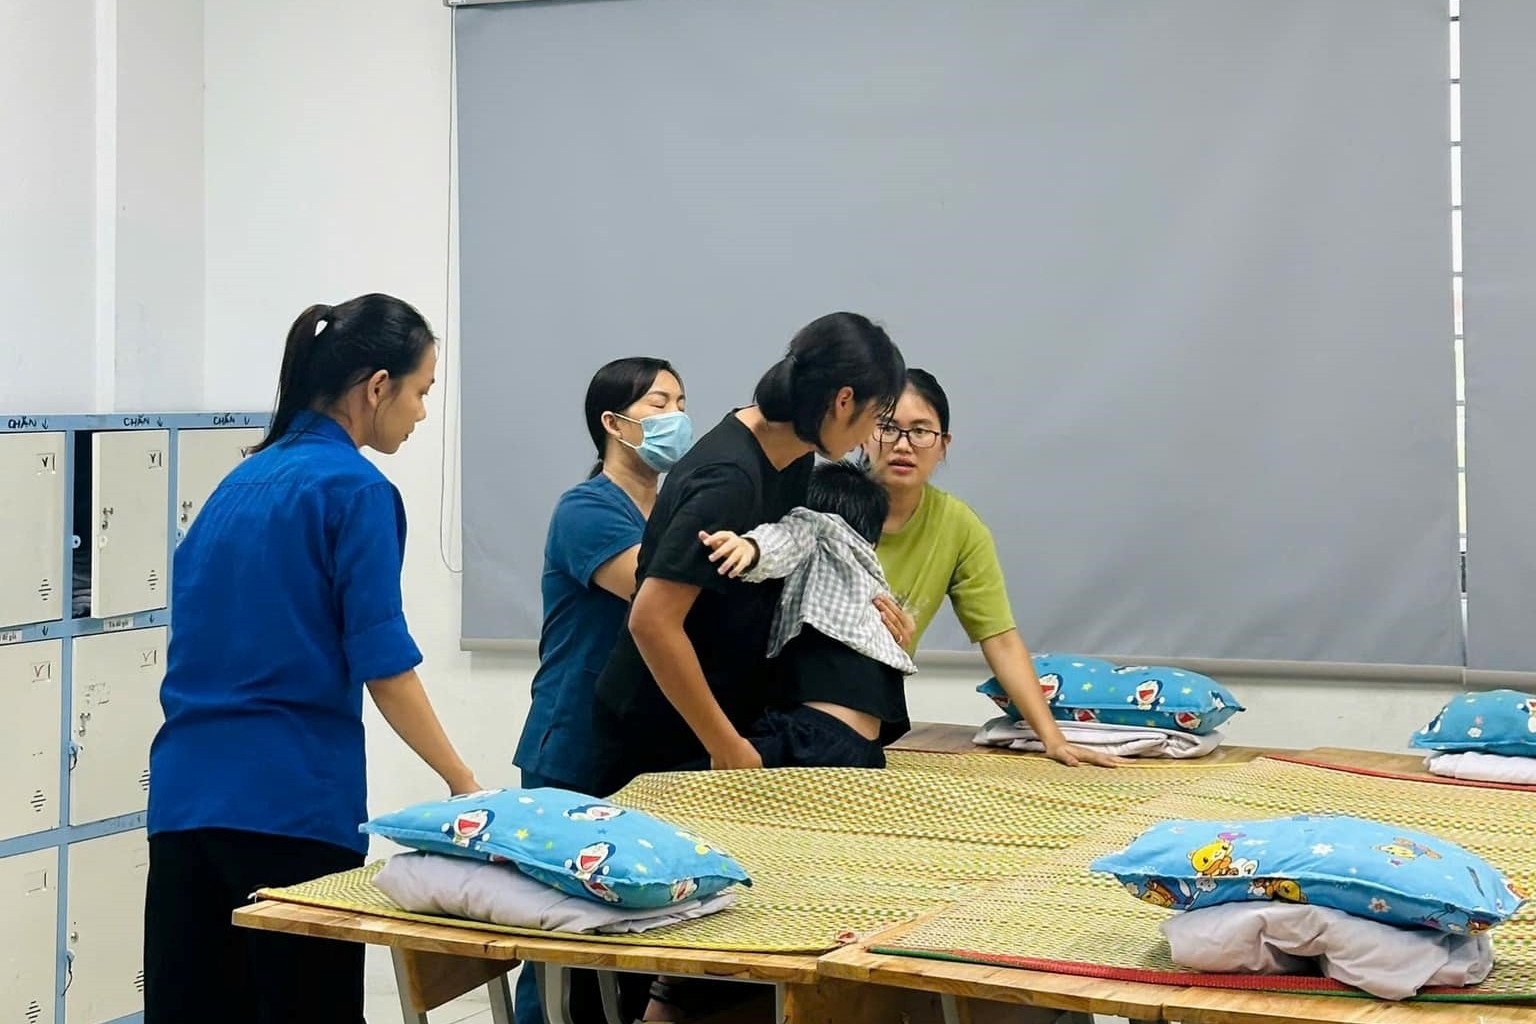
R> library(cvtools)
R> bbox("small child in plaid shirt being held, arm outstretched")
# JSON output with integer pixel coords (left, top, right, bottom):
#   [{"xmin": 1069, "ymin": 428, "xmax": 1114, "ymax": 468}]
[{"xmin": 700, "ymin": 462, "xmax": 917, "ymax": 768}]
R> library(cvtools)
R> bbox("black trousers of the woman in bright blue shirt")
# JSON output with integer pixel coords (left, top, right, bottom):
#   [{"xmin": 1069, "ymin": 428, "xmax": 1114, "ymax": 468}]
[{"xmin": 144, "ymin": 829, "xmax": 362, "ymax": 1024}]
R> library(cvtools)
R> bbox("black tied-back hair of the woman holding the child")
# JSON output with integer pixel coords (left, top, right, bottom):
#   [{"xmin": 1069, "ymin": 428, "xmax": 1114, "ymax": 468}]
[{"xmin": 753, "ymin": 313, "xmax": 906, "ymax": 454}]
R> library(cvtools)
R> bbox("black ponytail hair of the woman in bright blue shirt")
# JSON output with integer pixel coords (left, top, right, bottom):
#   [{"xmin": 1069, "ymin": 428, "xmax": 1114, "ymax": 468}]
[{"xmin": 253, "ymin": 293, "xmax": 438, "ymax": 451}]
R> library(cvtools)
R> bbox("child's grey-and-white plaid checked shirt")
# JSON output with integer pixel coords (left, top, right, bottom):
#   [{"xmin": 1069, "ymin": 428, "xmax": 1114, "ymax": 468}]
[{"xmin": 742, "ymin": 508, "xmax": 917, "ymax": 676}]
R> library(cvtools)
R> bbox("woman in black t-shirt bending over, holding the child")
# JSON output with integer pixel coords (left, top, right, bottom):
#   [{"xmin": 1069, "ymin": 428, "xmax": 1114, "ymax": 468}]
[{"xmin": 593, "ymin": 313, "xmax": 908, "ymax": 792}]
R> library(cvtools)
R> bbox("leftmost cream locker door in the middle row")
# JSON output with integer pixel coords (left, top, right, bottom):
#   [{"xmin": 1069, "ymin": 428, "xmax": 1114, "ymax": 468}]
[{"xmin": 0, "ymin": 640, "xmax": 65, "ymax": 841}]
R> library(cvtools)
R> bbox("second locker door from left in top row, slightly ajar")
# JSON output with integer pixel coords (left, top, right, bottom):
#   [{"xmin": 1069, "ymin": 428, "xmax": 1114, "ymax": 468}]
[{"xmin": 89, "ymin": 430, "xmax": 170, "ymax": 619}]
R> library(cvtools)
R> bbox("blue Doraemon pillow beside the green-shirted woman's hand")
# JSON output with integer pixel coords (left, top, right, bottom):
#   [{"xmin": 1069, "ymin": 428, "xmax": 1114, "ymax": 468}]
[{"xmin": 977, "ymin": 654, "xmax": 1246, "ymax": 735}]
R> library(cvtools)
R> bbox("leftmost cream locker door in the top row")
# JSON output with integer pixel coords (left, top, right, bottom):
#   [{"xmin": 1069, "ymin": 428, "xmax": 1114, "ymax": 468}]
[{"xmin": 0, "ymin": 431, "xmax": 69, "ymax": 626}]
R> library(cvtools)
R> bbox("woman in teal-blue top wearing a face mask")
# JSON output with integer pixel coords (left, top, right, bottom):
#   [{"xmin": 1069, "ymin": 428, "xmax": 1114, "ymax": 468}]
[{"xmin": 513, "ymin": 356, "xmax": 693, "ymax": 792}]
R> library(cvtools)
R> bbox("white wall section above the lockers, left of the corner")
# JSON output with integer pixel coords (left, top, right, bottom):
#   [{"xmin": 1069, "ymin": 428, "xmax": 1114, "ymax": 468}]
[{"xmin": 0, "ymin": 0, "xmax": 203, "ymax": 413}]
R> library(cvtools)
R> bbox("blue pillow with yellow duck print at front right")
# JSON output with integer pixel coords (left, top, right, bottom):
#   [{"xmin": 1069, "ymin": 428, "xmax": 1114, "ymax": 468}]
[{"xmin": 1092, "ymin": 815, "xmax": 1524, "ymax": 935}]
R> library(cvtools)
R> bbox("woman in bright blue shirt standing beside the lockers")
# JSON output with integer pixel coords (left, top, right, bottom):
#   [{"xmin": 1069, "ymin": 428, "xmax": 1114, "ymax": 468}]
[{"xmin": 144, "ymin": 295, "xmax": 479, "ymax": 1024}]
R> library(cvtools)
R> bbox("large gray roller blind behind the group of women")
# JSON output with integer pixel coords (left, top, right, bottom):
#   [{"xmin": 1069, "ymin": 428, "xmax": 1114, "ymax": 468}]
[{"xmin": 455, "ymin": 0, "xmax": 1462, "ymax": 665}]
